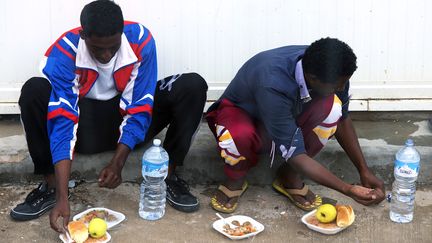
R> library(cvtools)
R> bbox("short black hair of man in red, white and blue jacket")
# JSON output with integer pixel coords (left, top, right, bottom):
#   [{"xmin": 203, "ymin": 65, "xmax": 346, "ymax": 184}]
[{"xmin": 80, "ymin": 0, "xmax": 124, "ymax": 37}]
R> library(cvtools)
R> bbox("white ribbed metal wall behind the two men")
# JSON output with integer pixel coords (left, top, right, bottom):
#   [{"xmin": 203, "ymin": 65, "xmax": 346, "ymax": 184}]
[{"xmin": 0, "ymin": 0, "xmax": 432, "ymax": 113}]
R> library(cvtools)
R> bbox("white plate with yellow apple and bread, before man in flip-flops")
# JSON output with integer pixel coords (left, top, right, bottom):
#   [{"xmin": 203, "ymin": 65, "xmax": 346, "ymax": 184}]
[{"xmin": 301, "ymin": 204, "xmax": 355, "ymax": 235}]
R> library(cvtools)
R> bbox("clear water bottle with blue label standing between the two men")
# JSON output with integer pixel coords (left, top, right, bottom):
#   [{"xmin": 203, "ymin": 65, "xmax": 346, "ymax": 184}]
[{"xmin": 139, "ymin": 139, "xmax": 169, "ymax": 220}]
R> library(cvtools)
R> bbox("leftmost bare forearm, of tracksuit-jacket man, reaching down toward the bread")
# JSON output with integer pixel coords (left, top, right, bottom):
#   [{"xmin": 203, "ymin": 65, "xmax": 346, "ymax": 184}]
[{"xmin": 55, "ymin": 160, "xmax": 72, "ymax": 200}]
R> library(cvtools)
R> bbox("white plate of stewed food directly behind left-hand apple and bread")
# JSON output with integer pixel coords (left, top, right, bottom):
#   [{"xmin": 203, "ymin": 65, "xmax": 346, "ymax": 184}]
[{"xmin": 73, "ymin": 208, "xmax": 126, "ymax": 229}]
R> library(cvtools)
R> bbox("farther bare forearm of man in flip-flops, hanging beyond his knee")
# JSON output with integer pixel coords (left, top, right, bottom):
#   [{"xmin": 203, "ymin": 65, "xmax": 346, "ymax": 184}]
[{"xmin": 335, "ymin": 117, "xmax": 369, "ymax": 174}]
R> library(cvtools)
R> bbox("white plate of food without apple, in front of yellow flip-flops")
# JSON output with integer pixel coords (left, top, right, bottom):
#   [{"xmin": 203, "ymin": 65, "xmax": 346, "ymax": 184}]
[{"xmin": 213, "ymin": 215, "xmax": 264, "ymax": 240}]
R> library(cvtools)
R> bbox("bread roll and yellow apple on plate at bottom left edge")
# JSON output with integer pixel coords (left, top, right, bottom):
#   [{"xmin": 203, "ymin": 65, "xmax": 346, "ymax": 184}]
[{"xmin": 59, "ymin": 218, "xmax": 111, "ymax": 243}]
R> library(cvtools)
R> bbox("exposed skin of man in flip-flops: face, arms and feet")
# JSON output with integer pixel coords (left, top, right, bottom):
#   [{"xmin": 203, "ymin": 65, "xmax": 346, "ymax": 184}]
[{"xmin": 215, "ymin": 73, "xmax": 385, "ymax": 208}]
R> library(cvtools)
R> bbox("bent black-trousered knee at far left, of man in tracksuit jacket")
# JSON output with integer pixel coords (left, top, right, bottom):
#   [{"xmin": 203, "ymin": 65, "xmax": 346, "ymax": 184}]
[{"xmin": 18, "ymin": 77, "xmax": 51, "ymax": 107}]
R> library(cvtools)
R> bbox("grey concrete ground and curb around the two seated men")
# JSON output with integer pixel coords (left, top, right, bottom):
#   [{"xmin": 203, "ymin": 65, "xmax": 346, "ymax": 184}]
[{"xmin": 0, "ymin": 112, "xmax": 432, "ymax": 243}]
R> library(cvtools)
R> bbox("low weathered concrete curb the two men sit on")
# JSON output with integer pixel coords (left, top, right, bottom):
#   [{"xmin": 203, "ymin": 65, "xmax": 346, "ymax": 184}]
[{"xmin": 0, "ymin": 121, "xmax": 432, "ymax": 185}]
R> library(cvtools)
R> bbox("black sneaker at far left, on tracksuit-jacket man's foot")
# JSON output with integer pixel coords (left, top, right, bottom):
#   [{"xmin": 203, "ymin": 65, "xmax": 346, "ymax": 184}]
[{"xmin": 10, "ymin": 182, "xmax": 56, "ymax": 221}]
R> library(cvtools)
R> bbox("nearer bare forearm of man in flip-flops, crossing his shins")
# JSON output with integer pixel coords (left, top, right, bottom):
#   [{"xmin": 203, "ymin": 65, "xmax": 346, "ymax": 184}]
[{"xmin": 288, "ymin": 154, "xmax": 351, "ymax": 195}]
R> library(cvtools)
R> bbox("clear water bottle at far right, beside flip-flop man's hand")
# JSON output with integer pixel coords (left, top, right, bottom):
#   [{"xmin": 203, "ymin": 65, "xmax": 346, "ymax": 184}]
[{"xmin": 390, "ymin": 139, "xmax": 420, "ymax": 223}]
